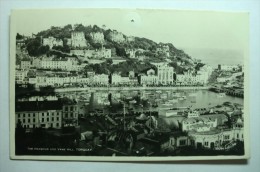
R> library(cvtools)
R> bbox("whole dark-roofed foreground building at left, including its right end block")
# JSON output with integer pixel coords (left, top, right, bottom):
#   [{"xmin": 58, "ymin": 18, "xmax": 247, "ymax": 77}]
[{"xmin": 15, "ymin": 101, "xmax": 78, "ymax": 129}]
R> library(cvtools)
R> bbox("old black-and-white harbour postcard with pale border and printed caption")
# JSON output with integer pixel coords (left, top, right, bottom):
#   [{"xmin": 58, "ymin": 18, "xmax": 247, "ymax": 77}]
[{"xmin": 10, "ymin": 9, "xmax": 249, "ymax": 161}]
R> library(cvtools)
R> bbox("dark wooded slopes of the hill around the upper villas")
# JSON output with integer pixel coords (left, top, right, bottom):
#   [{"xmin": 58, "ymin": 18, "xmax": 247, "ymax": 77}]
[{"xmin": 17, "ymin": 24, "xmax": 199, "ymax": 73}]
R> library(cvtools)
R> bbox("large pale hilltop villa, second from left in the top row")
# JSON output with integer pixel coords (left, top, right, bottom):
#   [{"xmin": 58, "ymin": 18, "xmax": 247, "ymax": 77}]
[{"xmin": 67, "ymin": 31, "xmax": 87, "ymax": 48}]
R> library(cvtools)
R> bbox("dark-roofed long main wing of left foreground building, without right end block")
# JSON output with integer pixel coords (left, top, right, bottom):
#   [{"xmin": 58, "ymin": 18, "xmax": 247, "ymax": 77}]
[{"xmin": 15, "ymin": 101, "xmax": 62, "ymax": 129}]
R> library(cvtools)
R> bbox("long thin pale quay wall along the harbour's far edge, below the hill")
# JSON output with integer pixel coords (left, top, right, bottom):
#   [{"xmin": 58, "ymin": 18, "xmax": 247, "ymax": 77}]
[{"xmin": 54, "ymin": 86, "xmax": 209, "ymax": 93}]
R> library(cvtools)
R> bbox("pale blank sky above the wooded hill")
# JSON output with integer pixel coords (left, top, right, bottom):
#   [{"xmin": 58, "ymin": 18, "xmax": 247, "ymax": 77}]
[{"xmin": 12, "ymin": 9, "xmax": 248, "ymax": 64}]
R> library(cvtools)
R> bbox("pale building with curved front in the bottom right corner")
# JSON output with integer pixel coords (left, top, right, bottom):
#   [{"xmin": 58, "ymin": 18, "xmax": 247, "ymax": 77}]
[{"xmin": 167, "ymin": 118, "xmax": 244, "ymax": 150}]
